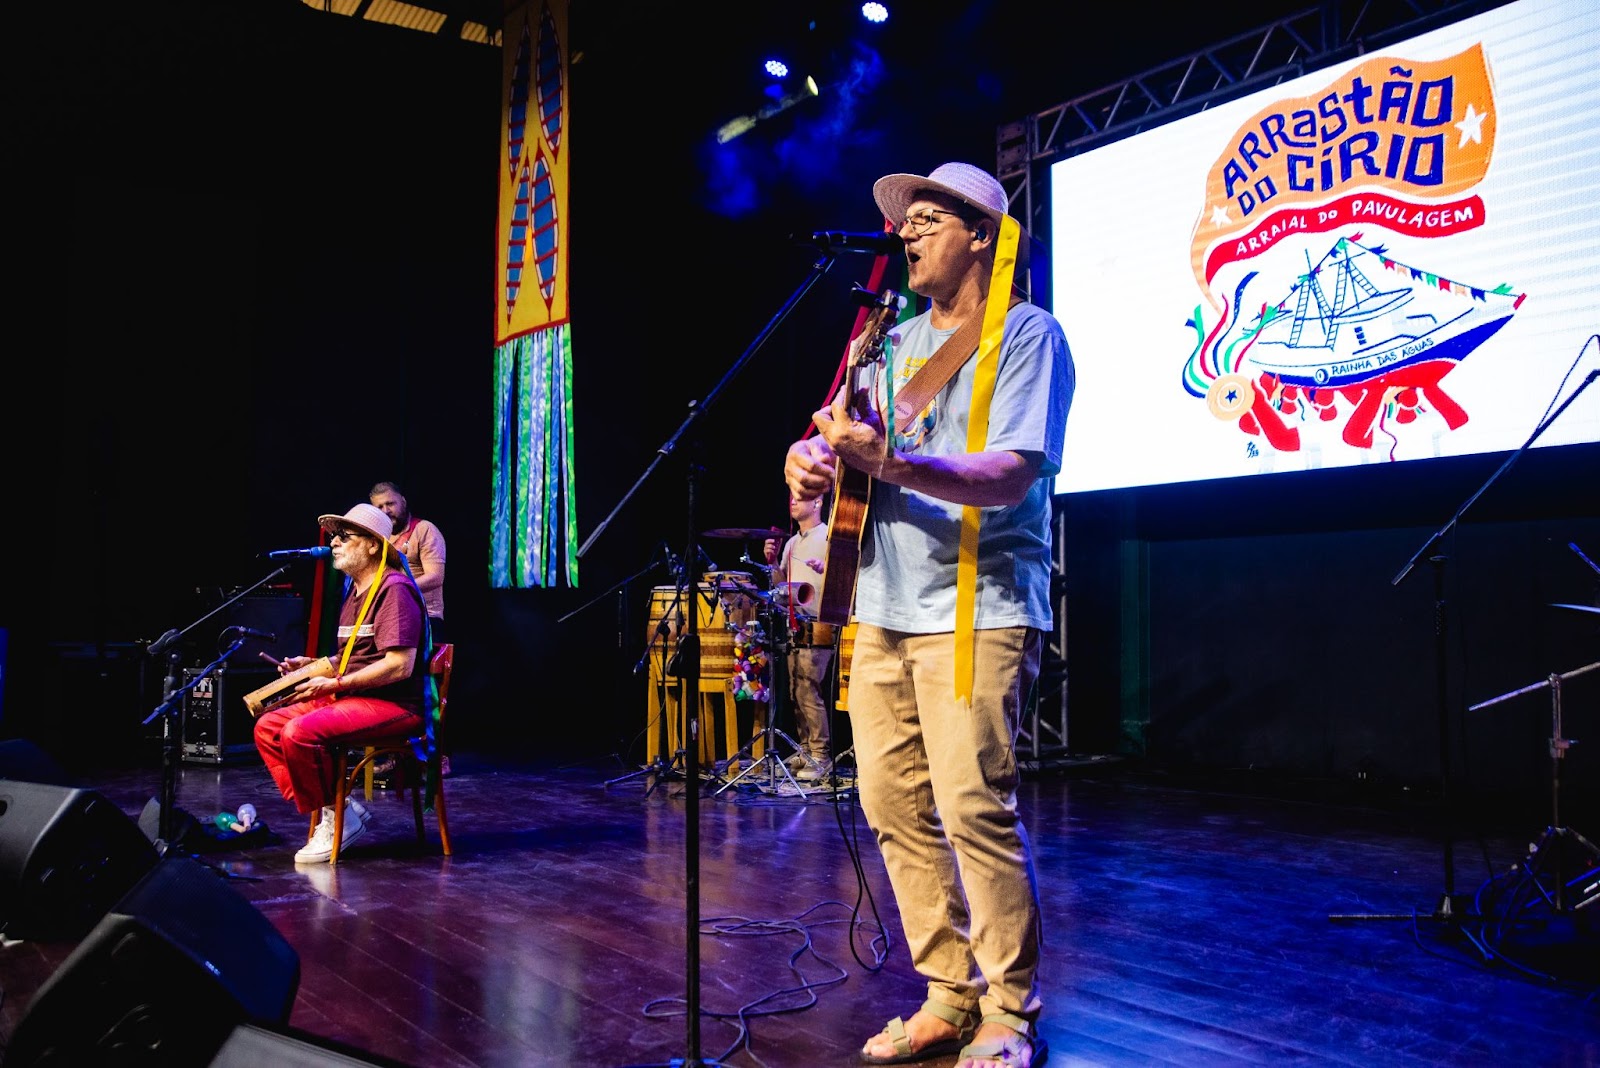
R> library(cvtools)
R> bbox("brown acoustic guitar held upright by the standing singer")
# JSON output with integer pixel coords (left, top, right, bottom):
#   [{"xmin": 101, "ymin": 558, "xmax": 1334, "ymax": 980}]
[{"xmin": 816, "ymin": 286, "xmax": 899, "ymax": 627}]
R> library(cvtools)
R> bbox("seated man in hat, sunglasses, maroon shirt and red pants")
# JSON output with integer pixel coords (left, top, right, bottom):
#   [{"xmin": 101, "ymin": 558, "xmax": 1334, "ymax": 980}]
[{"xmin": 256, "ymin": 504, "xmax": 427, "ymax": 863}]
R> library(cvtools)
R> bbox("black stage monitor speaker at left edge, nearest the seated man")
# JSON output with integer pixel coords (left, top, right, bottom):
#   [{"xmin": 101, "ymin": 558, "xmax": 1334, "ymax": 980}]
[{"xmin": 0, "ymin": 779, "xmax": 157, "ymax": 942}]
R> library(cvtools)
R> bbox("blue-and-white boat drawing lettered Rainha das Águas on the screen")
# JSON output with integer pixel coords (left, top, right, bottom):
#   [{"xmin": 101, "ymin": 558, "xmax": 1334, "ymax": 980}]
[{"xmin": 1250, "ymin": 238, "xmax": 1522, "ymax": 389}]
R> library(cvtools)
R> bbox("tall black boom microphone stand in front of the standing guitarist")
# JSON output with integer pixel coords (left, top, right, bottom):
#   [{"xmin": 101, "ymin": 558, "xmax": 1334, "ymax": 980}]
[{"xmin": 578, "ymin": 251, "xmax": 837, "ymax": 1068}]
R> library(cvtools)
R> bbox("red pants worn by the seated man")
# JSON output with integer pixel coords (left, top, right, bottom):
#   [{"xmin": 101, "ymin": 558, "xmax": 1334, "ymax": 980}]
[{"xmin": 256, "ymin": 694, "xmax": 424, "ymax": 815}]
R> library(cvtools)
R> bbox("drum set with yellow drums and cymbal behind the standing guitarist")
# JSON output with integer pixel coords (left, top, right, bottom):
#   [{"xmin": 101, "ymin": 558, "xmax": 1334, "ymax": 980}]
[{"xmin": 646, "ymin": 528, "xmax": 821, "ymax": 790}]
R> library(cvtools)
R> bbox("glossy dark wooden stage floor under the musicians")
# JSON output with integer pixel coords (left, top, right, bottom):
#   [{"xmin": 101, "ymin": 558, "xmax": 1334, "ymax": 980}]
[{"xmin": 0, "ymin": 753, "xmax": 1600, "ymax": 1068}]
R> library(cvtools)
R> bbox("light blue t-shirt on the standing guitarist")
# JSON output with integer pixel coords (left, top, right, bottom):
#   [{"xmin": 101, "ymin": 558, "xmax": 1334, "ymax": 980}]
[{"xmin": 856, "ymin": 304, "xmax": 1074, "ymax": 633}]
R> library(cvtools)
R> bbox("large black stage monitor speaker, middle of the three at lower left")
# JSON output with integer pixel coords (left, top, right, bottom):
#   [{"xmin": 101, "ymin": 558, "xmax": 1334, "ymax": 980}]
[{"xmin": 5, "ymin": 855, "xmax": 299, "ymax": 1068}]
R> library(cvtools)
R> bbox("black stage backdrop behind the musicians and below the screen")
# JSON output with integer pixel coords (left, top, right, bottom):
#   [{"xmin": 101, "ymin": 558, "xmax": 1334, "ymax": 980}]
[{"xmin": 0, "ymin": 0, "xmax": 1600, "ymax": 824}]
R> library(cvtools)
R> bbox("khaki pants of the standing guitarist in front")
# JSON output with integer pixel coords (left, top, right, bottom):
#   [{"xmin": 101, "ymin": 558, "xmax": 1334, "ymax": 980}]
[{"xmin": 850, "ymin": 624, "xmax": 1043, "ymax": 1020}]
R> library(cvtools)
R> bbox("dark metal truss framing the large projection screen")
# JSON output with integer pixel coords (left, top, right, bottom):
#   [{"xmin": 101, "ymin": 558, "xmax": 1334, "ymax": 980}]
[{"xmin": 995, "ymin": 0, "xmax": 1510, "ymax": 766}]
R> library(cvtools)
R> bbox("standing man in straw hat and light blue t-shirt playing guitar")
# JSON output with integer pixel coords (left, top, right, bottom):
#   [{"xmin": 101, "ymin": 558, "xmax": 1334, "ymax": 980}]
[{"xmin": 784, "ymin": 163, "xmax": 1072, "ymax": 1068}]
